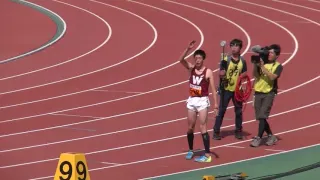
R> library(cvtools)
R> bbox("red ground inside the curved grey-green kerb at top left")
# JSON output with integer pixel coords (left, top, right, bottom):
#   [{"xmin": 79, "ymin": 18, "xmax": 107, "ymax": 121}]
[{"xmin": 0, "ymin": 1, "xmax": 56, "ymax": 61}]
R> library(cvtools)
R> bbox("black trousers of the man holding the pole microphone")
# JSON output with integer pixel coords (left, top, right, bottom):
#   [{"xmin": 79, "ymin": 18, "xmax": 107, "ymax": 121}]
[{"xmin": 213, "ymin": 91, "xmax": 242, "ymax": 132}]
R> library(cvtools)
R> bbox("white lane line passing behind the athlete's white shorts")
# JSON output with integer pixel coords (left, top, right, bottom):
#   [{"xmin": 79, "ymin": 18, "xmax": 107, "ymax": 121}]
[{"xmin": 0, "ymin": 76, "xmax": 320, "ymax": 138}]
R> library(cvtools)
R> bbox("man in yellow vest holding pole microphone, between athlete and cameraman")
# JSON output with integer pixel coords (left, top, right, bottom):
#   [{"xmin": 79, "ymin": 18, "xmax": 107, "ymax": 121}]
[{"xmin": 213, "ymin": 39, "xmax": 247, "ymax": 140}]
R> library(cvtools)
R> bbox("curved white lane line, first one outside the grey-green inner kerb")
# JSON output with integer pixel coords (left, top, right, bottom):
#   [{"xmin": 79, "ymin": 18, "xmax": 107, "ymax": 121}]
[{"xmin": 0, "ymin": 0, "xmax": 112, "ymax": 81}]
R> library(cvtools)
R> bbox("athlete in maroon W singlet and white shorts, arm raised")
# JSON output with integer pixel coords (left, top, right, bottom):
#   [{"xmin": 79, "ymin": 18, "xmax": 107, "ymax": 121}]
[{"xmin": 179, "ymin": 41, "xmax": 218, "ymax": 162}]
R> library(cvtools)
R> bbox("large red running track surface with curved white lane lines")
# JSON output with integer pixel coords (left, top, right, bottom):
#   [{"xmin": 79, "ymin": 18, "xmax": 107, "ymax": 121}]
[{"xmin": 0, "ymin": 0, "xmax": 320, "ymax": 179}]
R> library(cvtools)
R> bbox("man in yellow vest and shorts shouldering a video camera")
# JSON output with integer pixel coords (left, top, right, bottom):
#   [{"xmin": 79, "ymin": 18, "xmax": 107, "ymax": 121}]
[{"xmin": 251, "ymin": 44, "xmax": 283, "ymax": 147}]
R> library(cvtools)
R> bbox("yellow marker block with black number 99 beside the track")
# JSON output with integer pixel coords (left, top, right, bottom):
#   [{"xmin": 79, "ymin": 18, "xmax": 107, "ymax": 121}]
[{"xmin": 54, "ymin": 154, "xmax": 90, "ymax": 180}]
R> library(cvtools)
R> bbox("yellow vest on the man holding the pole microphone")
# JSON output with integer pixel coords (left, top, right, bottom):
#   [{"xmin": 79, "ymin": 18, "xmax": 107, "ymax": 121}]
[{"xmin": 223, "ymin": 56, "xmax": 243, "ymax": 92}]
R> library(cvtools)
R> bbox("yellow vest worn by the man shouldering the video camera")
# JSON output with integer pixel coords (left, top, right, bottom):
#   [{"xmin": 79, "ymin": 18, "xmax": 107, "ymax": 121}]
[{"xmin": 254, "ymin": 62, "xmax": 280, "ymax": 93}]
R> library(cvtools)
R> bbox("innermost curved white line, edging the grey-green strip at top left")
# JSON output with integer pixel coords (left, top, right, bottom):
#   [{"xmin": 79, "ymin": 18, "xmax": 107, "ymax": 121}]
[{"xmin": 0, "ymin": 0, "xmax": 67, "ymax": 64}]
